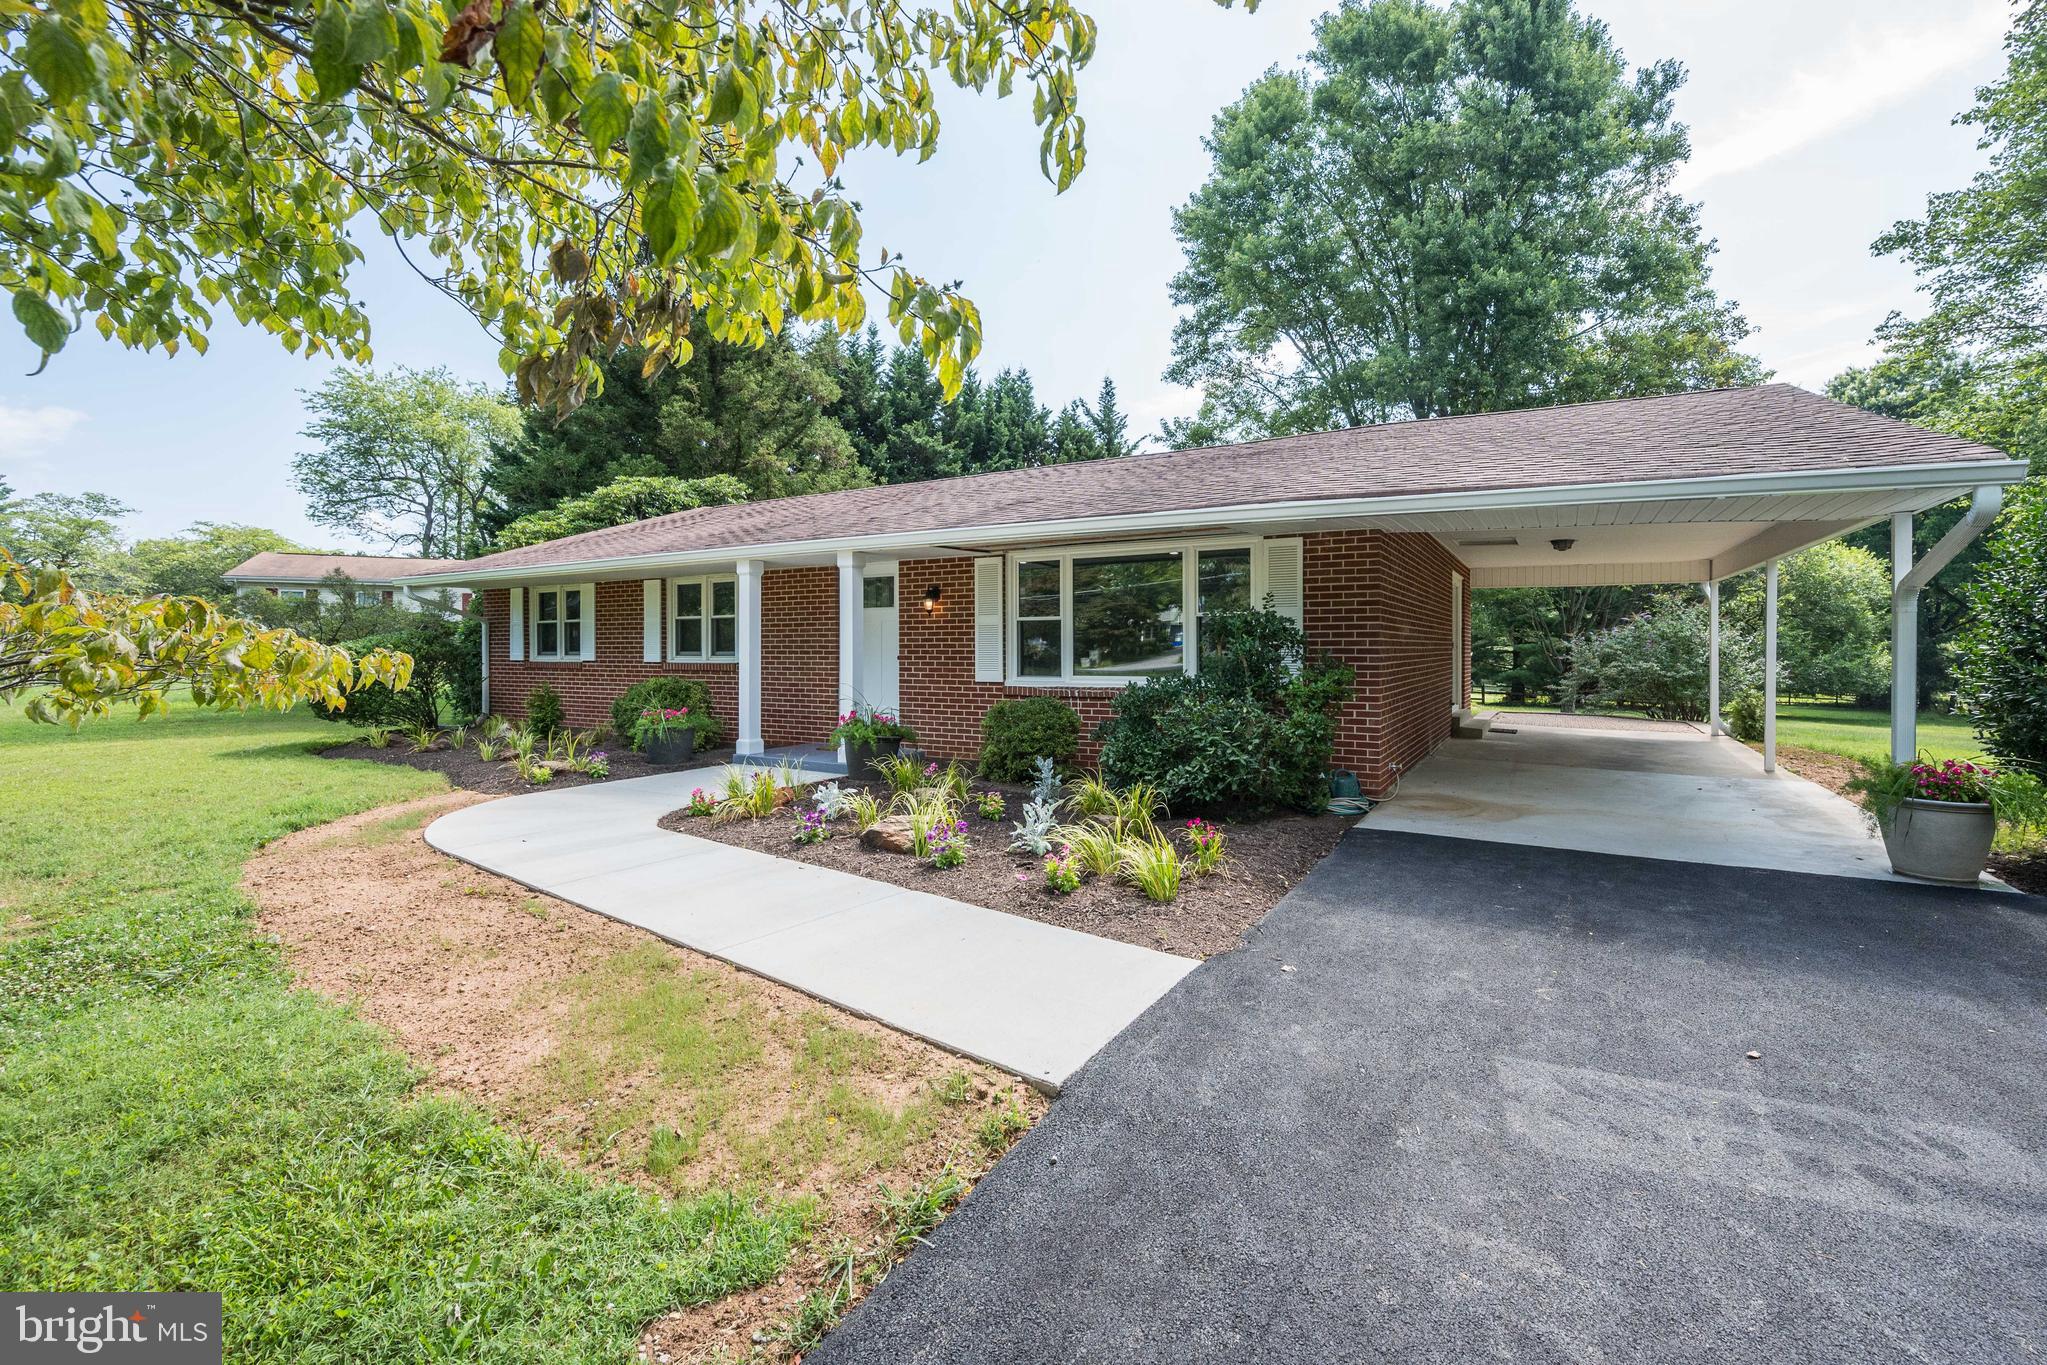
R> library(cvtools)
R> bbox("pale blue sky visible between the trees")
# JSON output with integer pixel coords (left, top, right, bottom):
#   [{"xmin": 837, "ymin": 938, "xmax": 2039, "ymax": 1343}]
[{"xmin": 0, "ymin": 0, "xmax": 2010, "ymax": 551}]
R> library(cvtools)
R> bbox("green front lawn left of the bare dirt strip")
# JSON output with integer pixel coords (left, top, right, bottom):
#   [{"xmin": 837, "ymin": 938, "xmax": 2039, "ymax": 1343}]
[{"xmin": 0, "ymin": 704, "xmax": 802, "ymax": 1363}]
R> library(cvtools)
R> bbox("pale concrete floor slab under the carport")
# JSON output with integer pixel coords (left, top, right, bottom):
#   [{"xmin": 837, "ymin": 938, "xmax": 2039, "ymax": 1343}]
[{"xmin": 1361, "ymin": 714, "xmax": 2000, "ymax": 886}]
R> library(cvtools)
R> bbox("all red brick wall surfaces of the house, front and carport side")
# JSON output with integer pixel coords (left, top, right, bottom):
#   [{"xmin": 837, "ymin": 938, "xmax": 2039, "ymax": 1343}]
[{"xmin": 483, "ymin": 530, "xmax": 1472, "ymax": 794}]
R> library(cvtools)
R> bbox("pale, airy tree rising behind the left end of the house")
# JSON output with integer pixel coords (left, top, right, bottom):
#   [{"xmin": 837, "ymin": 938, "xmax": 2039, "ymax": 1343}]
[{"xmin": 291, "ymin": 368, "xmax": 520, "ymax": 559}]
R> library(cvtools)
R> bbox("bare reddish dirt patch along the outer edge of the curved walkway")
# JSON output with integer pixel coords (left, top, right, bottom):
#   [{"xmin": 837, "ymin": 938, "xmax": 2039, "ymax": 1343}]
[{"xmin": 244, "ymin": 792, "xmax": 1044, "ymax": 1361}]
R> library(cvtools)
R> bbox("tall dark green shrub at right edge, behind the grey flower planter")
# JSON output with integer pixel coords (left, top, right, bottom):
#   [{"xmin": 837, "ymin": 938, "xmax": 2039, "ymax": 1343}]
[{"xmin": 1953, "ymin": 481, "xmax": 2047, "ymax": 774}]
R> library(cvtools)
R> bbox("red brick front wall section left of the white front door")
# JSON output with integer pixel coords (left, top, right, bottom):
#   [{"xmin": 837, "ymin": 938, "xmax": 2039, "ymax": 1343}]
[{"xmin": 483, "ymin": 569, "xmax": 839, "ymax": 745}]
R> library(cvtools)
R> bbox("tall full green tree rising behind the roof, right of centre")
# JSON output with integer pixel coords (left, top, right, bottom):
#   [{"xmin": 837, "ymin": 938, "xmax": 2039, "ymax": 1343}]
[{"xmin": 1167, "ymin": 0, "xmax": 1765, "ymax": 444}]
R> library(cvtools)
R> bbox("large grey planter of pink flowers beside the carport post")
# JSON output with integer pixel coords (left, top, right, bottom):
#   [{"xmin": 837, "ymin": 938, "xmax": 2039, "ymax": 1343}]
[{"xmin": 1848, "ymin": 759, "xmax": 2047, "ymax": 886}]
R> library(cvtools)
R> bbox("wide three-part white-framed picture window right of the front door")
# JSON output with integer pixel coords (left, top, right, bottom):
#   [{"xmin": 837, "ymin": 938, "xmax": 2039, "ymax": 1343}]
[{"xmin": 1009, "ymin": 542, "xmax": 1251, "ymax": 684}]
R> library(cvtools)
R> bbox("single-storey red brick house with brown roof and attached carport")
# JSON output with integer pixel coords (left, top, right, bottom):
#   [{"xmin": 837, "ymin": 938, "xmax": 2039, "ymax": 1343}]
[{"xmin": 407, "ymin": 385, "xmax": 2024, "ymax": 792}]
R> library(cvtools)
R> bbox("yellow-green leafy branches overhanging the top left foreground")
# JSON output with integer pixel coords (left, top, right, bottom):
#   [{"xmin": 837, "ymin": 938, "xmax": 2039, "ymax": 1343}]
[{"xmin": 0, "ymin": 0, "xmax": 1228, "ymax": 407}]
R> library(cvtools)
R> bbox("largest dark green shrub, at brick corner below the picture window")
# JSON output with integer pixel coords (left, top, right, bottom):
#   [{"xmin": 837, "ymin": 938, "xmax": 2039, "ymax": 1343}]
[{"xmin": 1101, "ymin": 612, "xmax": 1351, "ymax": 812}]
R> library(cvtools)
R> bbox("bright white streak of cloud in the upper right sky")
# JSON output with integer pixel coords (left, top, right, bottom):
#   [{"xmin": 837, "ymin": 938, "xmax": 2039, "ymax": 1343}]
[{"xmin": 1676, "ymin": 0, "xmax": 2010, "ymax": 192}]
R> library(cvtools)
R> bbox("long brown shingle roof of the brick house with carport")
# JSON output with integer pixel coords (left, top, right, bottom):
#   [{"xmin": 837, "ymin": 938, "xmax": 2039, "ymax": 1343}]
[{"xmin": 436, "ymin": 385, "xmax": 2000, "ymax": 569}]
